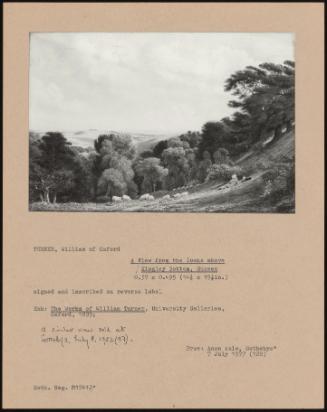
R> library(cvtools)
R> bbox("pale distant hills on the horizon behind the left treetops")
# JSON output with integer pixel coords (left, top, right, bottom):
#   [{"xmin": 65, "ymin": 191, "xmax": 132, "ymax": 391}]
[{"xmin": 30, "ymin": 129, "xmax": 178, "ymax": 152}]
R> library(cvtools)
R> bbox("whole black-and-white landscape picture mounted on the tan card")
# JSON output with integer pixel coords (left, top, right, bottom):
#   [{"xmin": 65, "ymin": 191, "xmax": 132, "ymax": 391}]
[{"xmin": 29, "ymin": 33, "xmax": 295, "ymax": 213}]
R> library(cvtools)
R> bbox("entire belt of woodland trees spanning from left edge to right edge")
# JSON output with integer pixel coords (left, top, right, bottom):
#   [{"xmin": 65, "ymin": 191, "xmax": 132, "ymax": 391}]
[{"xmin": 29, "ymin": 61, "xmax": 295, "ymax": 202}]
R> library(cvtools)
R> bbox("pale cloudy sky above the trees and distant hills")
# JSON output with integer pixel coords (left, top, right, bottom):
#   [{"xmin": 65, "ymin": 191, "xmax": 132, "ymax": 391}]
[{"xmin": 29, "ymin": 33, "xmax": 294, "ymax": 133}]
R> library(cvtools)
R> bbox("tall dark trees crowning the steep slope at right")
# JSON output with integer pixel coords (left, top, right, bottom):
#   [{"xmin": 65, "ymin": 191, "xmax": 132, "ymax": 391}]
[{"xmin": 199, "ymin": 61, "xmax": 295, "ymax": 156}]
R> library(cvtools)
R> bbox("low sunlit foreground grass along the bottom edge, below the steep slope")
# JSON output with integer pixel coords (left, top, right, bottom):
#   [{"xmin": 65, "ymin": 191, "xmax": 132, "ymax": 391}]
[{"xmin": 30, "ymin": 175, "xmax": 294, "ymax": 213}]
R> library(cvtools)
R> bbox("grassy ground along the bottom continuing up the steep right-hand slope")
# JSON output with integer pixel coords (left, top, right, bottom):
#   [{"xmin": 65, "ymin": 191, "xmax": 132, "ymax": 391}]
[{"xmin": 31, "ymin": 132, "xmax": 295, "ymax": 213}]
